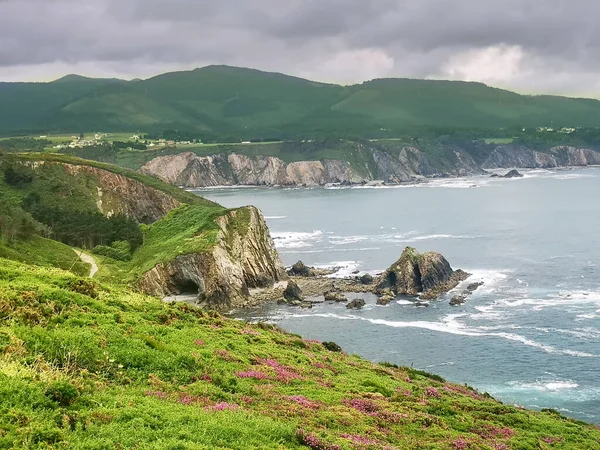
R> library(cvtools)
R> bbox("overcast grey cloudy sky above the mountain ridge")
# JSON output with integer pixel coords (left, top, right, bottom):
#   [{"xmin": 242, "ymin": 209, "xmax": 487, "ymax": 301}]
[{"xmin": 0, "ymin": 0, "xmax": 600, "ymax": 98}]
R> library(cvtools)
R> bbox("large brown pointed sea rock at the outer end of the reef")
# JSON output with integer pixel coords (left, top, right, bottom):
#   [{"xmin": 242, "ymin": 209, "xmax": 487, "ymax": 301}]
[{"xmin": 377, "ymin": 247, "xmax": 469, "ymax": 299}]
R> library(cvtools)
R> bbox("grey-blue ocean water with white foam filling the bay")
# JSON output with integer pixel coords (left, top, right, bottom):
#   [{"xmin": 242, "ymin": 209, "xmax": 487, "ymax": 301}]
[{"xmin": 192, "ymin": 168, "xmax": 600, "ymax": 423}]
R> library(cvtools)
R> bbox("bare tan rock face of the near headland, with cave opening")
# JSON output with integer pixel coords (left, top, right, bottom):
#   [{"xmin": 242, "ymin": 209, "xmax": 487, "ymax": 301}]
[{"xmin": 139, "ymin": 207, "xmax": 288, "ymax": 310}]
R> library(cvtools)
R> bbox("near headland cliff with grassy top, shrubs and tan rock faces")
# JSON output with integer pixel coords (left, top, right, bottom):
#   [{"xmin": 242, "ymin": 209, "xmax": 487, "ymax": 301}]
[{"xmin": 0, "ymin": 155, "xmax": 287, "ymax": 309}]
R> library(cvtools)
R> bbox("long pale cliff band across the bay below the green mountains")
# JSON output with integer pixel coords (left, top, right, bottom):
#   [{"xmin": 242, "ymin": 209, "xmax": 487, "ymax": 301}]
[{"xmin": 140, "ymin": 142, "xmax": 600, "ymax": 188}]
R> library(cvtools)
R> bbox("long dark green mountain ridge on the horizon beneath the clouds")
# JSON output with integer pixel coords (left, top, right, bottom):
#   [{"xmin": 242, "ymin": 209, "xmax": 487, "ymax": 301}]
[{"xmin": 0, "ymin": 66, "xmax": 600, "ymax": 138}]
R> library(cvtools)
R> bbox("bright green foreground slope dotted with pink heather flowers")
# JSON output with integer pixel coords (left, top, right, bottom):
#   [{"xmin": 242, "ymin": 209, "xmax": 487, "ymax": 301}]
[{"xmin": 0, "ymin": 259, "xmax": 600, "ymax": 450}]
